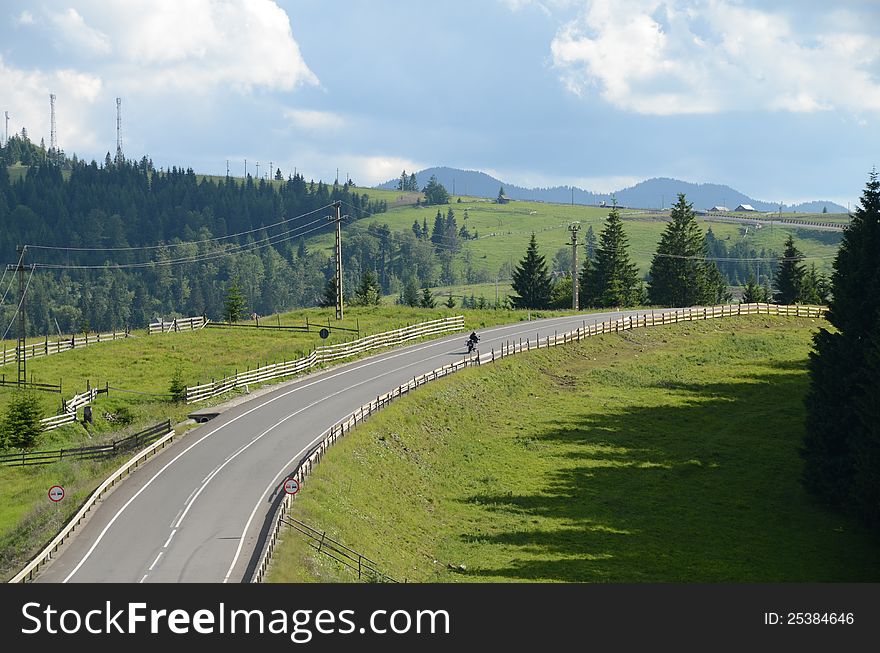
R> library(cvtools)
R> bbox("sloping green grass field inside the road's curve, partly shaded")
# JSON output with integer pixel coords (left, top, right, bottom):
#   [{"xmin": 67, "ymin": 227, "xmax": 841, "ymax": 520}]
[{"xmin": 269, "ymin": 316, "xmax": 880, "ymax": 582}]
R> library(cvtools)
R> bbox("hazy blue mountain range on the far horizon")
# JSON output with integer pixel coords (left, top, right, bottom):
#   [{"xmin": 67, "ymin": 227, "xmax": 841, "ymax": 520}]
[{"xmin": 377, "ymin": 167, "xmax": 846, "ymax": 213}]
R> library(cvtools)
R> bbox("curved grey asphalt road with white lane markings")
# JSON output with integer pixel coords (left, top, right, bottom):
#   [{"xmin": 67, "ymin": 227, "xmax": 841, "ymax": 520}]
[{"xmin": 37, "ymin": 309, "xmax": 672, "ymax": 583}]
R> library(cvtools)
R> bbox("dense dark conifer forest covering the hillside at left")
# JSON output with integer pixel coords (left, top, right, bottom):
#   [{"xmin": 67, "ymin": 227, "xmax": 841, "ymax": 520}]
[{"xmin": 0, "ymin": 135, "xmax": 386, "ymax": 334}]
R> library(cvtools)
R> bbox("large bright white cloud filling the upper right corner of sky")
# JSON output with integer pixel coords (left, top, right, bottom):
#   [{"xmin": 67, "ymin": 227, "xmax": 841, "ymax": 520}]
[{"xmin": 551, "ymin": 0, "xmax": 880, "ymax": 115}]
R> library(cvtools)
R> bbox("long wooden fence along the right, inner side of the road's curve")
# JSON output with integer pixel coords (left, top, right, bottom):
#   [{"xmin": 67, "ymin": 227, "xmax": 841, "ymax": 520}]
[{"xmin": 251, "ymin": 304, "xmax": 828, "ymax": 583}]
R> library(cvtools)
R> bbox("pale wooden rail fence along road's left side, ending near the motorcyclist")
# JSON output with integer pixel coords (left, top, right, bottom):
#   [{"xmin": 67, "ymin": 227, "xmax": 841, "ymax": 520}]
[{"xmin": 186, "ymin": 315, "xmax": 464, "ymax": 404}]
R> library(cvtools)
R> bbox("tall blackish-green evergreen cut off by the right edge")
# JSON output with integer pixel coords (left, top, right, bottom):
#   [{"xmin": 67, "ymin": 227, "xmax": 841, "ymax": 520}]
[{"xmin": 802, "ymin": 171, "xmax": 880, "ymax": 527}]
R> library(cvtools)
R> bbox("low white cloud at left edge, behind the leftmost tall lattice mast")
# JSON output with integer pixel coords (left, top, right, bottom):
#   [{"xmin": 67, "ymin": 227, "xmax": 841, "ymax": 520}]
[{"xmin": 0, "ymin": 57, "xmax": 103, "ymax": 153}]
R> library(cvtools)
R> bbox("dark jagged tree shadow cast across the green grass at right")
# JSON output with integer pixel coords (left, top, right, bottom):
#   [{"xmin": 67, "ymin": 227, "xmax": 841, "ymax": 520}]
[{"xmin": 460, "ymin": 364, "xmax": 880, "ymax": 582}]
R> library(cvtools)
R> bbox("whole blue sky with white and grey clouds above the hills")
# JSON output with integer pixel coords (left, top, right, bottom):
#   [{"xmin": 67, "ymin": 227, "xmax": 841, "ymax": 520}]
[{"xmin": 0, "ymin": 0, "xmax": 880, "ymax": 206}]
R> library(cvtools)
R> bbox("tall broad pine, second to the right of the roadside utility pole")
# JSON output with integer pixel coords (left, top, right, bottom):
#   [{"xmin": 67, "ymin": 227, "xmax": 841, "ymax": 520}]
[{"xmin": 648, "ymin": 193, "xmax": 718, "ymax": 306}]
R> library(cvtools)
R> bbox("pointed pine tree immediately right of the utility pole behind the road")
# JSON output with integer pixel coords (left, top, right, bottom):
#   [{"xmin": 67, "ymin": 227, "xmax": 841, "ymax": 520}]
[{"xmin": 581, "ymin": 206, "xmax": 642, "ymax": 307}]
